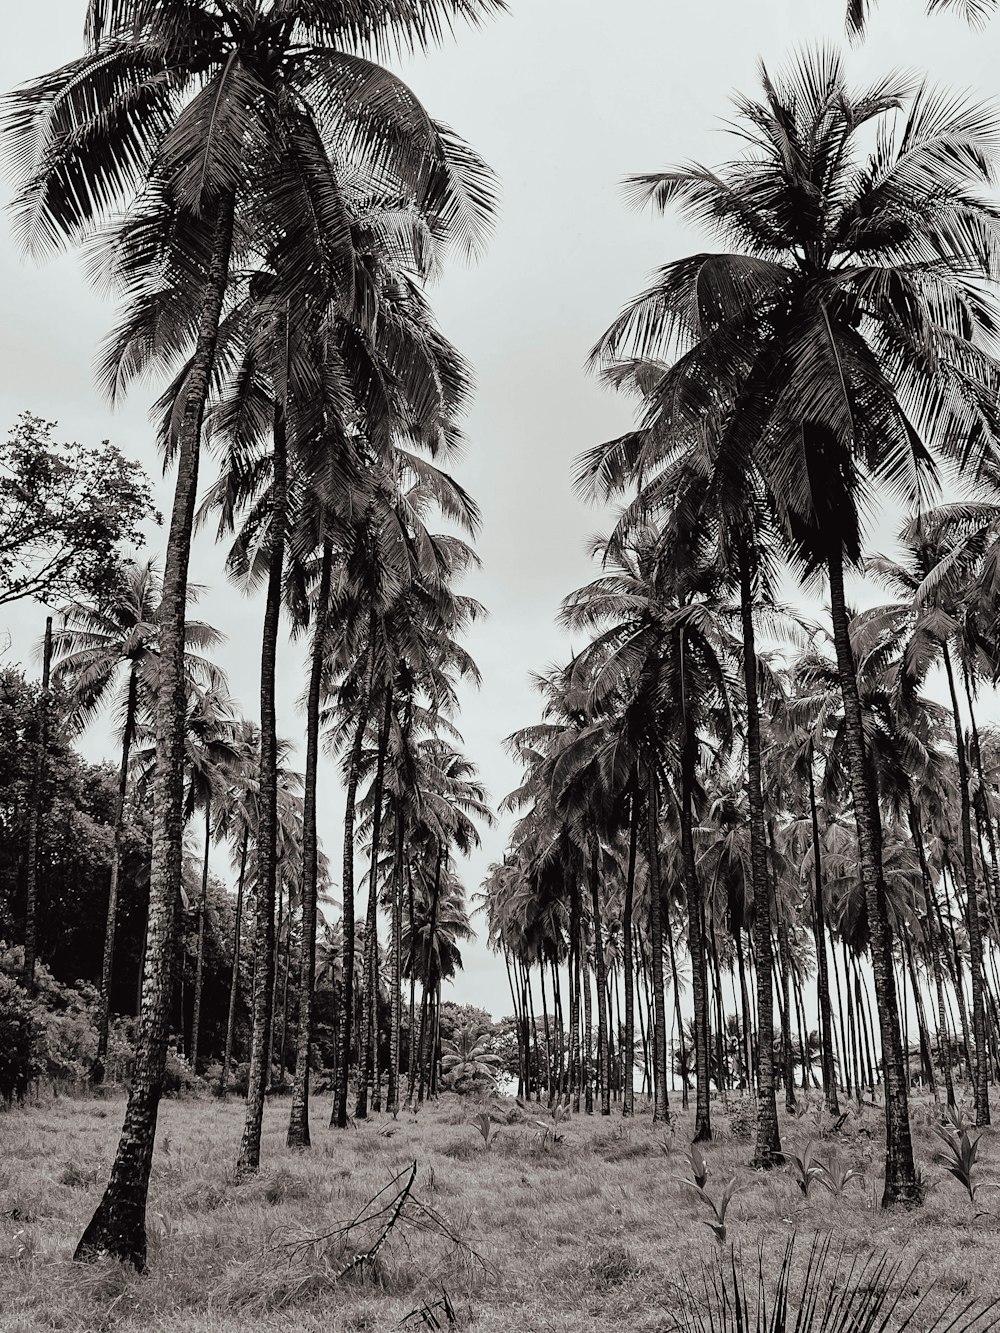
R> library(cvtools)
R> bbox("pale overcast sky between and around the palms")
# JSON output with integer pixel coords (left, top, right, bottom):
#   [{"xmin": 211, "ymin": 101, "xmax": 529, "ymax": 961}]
[{"xmin": 0, "ymin": 0, "xmax": 1000, "ymax": 1016}]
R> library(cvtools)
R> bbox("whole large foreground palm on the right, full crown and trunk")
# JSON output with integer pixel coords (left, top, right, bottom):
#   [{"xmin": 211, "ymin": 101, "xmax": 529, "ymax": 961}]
[{"xmin": 584, "ymin": 51, "xmax": 1000, "ymax": 1204}]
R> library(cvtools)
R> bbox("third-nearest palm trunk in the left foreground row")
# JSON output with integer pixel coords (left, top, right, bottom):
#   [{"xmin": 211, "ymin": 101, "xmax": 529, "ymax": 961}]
[{"xmin": 285, "ymin": 539, "xmax": 333, "ymax": 1148}]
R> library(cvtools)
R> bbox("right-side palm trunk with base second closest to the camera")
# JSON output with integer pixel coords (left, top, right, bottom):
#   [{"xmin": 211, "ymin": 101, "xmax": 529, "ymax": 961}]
[{"xmin": 740, "ymin": 551, "xmax": 781, "ymax": 1168}]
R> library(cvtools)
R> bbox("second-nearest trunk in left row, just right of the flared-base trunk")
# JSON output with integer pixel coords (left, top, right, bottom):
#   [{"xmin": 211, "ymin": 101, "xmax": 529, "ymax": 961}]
[{"xmin": 236, "ymin": 404, "xmax": 288, "ymax": 1178}]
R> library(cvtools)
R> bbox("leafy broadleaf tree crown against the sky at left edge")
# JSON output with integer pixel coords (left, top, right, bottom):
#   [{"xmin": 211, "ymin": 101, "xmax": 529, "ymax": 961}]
[{"xmin": 0, "ymin": 412, "xmax": 159, "ymax": 605}]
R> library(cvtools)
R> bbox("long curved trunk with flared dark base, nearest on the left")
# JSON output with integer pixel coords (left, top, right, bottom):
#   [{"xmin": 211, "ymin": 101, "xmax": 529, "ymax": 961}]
[{"xmin": 75, "ymin": 195, "xmax": 235, "ymax": 1269}]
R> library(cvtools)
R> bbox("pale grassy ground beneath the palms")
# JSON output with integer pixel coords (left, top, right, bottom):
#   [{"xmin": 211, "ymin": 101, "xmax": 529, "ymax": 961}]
[{"xmin": 0, "ymin": 1096, "xmax": 1000, "ymax": 1333}]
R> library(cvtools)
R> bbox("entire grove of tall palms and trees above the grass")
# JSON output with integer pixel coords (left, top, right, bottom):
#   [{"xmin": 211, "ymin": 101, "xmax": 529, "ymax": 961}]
[{"xmin": 0, "ymin": 0, "xmax": 1000, "ymax": 1279}]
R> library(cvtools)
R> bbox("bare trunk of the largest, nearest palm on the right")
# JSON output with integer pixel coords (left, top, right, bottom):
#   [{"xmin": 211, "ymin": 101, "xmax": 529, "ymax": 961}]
[{"xmin": 828, "ymin": 549, "xmax": 920, "ymax": 1208}]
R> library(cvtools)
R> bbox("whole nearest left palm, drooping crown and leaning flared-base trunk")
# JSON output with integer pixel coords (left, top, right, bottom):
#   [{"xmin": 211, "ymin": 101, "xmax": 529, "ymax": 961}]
[{"xmin": 5, "ymin": 0, "xmax": 503, "ymax": 1268}]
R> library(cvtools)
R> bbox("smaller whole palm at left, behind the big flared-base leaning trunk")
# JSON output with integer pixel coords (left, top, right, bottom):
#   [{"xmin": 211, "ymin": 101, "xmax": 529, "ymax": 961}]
[{"xmin": 53, "ymin": 560, "xmax": 224, "ymax": 1084}]
